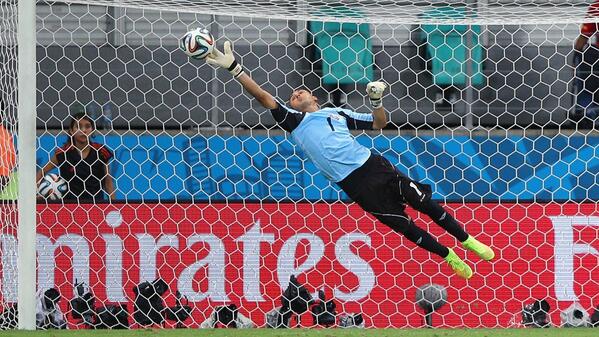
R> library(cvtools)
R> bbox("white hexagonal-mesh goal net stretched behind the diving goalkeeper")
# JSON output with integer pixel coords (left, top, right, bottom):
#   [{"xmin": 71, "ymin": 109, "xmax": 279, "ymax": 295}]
[{"xmin": 0, "ymin": 0, "xmax": 599, "ymax": 328}]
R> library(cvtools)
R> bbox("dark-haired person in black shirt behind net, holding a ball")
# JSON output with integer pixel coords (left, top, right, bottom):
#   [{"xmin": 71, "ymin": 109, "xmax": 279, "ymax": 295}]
[{"xmin": 37, "ymin": 113, "xmax": 115, "ymax": 202}]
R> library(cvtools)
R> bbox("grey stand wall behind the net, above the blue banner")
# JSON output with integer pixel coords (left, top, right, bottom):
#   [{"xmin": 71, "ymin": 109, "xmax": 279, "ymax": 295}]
[{"xmin": 27, "ymin": 2, "xmax": 586, "ymax": 130}]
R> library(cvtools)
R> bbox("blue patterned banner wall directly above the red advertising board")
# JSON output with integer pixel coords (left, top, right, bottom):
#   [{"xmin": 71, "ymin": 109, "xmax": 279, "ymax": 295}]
[{"xmin": 37, "ymin": 135, "xmax": 599, "ymax": 202}]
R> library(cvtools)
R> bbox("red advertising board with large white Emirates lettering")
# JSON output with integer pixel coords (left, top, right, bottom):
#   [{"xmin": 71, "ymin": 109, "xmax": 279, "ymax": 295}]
[{"xmin": 2, "ymin": 203, "xmax": 599, "ymax": 327}]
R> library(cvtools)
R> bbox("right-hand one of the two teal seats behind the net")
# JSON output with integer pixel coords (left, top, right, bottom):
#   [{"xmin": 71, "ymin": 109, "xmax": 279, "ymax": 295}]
[{"xmin": 421, "ymin": 6, "xmax": 484, "ymax": 108}]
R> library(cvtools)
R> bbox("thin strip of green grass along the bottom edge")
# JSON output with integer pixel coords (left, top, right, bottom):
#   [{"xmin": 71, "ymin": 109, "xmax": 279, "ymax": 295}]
[{"xmin": 0, "ymin": 328, "xmax": 599, "ymax": 337}]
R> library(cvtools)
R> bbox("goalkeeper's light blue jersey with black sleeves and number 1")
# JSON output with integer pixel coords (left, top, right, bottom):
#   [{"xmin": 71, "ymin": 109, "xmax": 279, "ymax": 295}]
[{"xmin": 271, "ymin": 103, "xmax": 374, "ymax": 182}]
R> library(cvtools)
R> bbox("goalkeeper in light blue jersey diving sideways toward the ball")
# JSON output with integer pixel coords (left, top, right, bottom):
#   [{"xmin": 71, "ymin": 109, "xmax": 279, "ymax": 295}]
[{"xmin": 186, "ymin": 41, "xmax": 495, "ymax": 279}]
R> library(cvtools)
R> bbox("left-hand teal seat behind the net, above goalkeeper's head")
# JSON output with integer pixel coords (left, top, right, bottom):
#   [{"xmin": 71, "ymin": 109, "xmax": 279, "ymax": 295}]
[{"xmin": 308, "ymin": 7, "xmax": 374, "ymax": 107}]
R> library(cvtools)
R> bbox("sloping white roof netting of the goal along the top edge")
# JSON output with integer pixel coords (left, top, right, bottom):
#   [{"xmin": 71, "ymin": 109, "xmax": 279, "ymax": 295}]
[{"xmin": 62, "ymin": 0, "xmax": 593, "ymax": 24}]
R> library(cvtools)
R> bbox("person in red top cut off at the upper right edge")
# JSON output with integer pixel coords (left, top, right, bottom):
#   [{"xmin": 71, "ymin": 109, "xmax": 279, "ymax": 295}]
[{"xmin": 571, "ymin": 0, "xmax": 599, "ymax": 121}]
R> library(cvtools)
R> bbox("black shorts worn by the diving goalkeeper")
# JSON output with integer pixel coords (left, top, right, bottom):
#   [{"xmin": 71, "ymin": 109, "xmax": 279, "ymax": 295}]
[{"xmin": 338, "ymin": 153, "xmax": 431, "ymax": 219}]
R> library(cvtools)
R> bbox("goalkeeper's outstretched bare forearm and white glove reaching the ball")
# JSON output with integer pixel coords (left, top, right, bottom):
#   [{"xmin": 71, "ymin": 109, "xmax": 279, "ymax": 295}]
[{"xmin": 206, "ymin": 41, "xmax": 278, "ymax": 109}]
